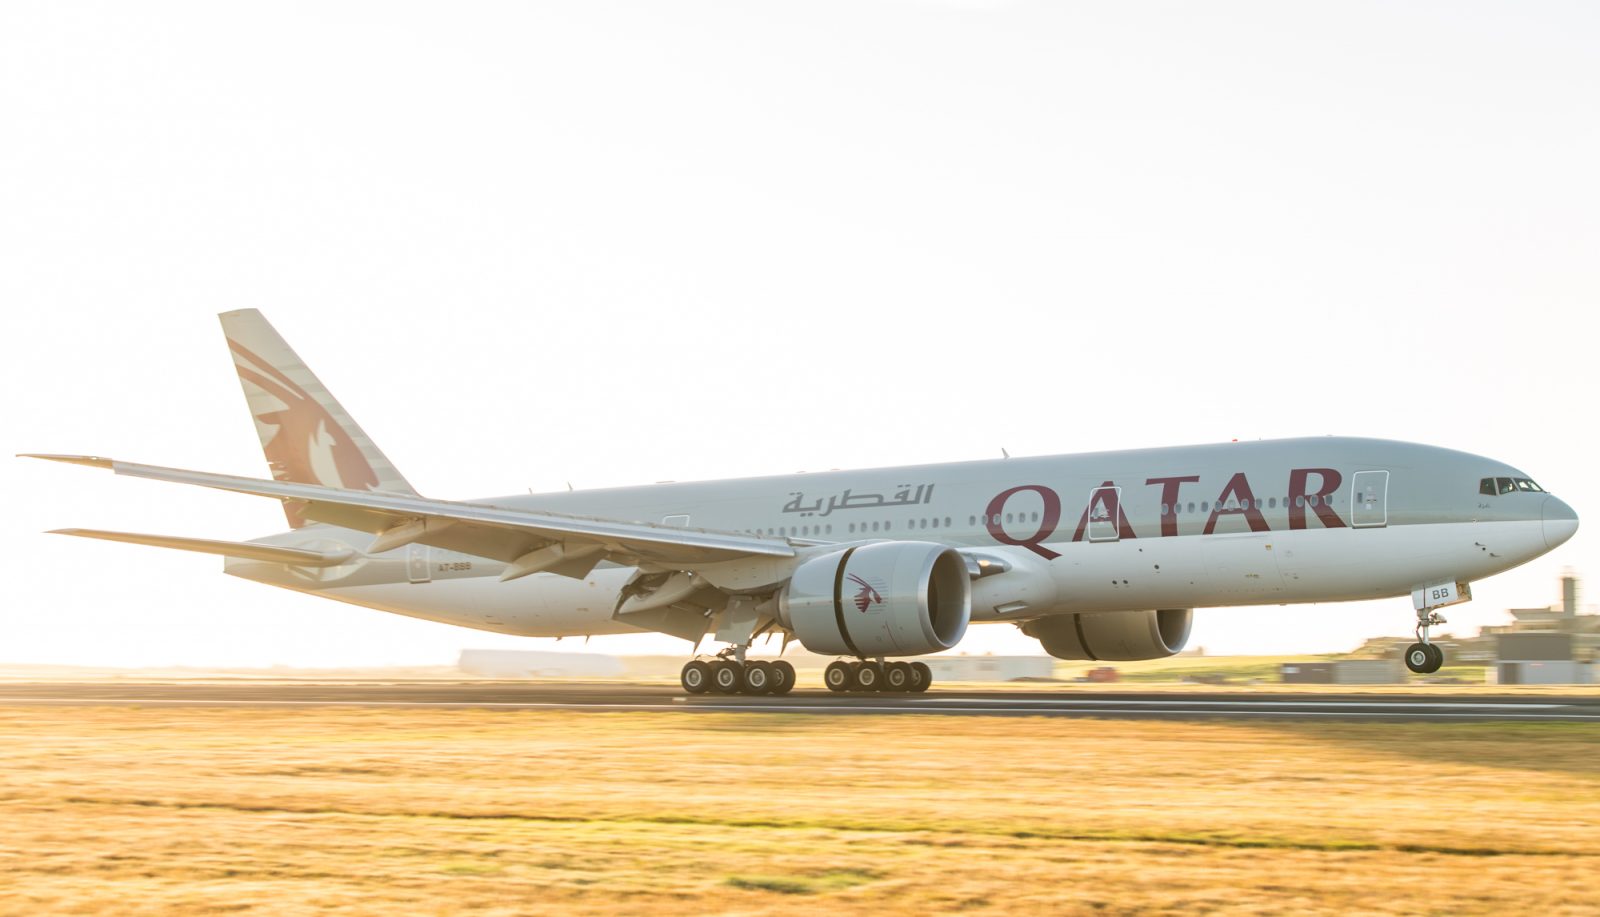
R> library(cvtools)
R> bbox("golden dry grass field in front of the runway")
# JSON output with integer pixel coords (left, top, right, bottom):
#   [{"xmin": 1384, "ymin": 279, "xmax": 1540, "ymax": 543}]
[{"xmin": 0, "ymin": 707, "xmax": 1600, "ymax": 915}]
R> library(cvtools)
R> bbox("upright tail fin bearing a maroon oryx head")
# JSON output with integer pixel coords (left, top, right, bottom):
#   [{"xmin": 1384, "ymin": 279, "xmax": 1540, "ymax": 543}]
[{"xmin": 219, "ymin": 309, "xmax": 416, "ymax": 528}]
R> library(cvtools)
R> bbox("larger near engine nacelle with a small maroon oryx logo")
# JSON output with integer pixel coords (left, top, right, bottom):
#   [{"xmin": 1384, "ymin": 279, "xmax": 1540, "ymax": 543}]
[{"xmin": 778, "ymin": 541, "xmax": 973, "ymax": 656}]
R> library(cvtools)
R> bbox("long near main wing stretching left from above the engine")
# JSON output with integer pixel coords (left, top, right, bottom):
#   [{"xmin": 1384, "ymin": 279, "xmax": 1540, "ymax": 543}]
[{"xmin": 22, "ymin": 454, "xmax": 795, "ymax": 579}]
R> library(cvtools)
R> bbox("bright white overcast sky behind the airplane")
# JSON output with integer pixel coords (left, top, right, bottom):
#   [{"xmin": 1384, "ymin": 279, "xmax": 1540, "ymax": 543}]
[{"xmin": 0, "ymin": 0, "xmax": 1600, "ymax": 664}]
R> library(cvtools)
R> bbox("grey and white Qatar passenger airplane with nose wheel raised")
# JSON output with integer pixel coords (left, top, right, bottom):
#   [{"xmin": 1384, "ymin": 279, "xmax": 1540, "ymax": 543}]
[{"xmin": 24, "ymin": 309, "xmax": 1578, "ymax": 695}]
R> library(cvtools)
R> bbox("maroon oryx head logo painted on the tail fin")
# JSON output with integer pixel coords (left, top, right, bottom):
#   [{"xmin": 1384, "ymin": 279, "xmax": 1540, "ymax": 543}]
[{"xmin": 227, "ymin": 338, "xmax": 378, "ymax": 523}]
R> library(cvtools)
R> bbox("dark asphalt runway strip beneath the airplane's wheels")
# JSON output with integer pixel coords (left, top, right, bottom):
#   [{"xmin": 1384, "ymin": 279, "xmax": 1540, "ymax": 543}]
[{"xmin": 0, "ymin": 682, "xmax": 1600, "ymax": 722}]
